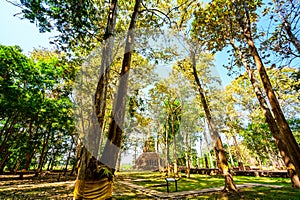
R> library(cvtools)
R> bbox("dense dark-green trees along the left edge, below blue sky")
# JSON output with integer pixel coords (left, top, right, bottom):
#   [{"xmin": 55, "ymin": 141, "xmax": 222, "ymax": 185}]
[{"xmin": 0, "ymin": 45, "xmax": 76, "ymax": 173}]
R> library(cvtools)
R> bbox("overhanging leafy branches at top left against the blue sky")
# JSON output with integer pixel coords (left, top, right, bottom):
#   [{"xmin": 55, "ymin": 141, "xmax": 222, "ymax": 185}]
[{"xmin": 20, "ymin": 0, "xmax": 109, "ymax": 51}]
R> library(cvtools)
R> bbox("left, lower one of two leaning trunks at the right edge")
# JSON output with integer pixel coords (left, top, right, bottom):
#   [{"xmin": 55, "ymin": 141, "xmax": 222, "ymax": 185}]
[{"xmin": 231, "ymin": 40, "xmax": 300, "ymax": 188}]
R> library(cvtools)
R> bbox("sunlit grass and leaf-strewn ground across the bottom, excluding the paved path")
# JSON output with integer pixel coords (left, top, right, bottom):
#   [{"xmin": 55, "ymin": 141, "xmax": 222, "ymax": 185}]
[{"xmin": 0, "ymin": 172, "xmax": 300, "ymax": 200}]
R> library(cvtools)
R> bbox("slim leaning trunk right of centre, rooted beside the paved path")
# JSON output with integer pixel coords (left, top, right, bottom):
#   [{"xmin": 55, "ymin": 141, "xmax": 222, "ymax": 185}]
[{"xmin": 191, "ymin": 52, "xmax": 238, "ymax": 191}]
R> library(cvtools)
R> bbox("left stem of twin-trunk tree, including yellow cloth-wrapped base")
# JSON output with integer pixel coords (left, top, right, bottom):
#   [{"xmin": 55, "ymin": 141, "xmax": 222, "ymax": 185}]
[{"xmin": 74, "ymin": 0, "xmax": 118, "ymax": 200}]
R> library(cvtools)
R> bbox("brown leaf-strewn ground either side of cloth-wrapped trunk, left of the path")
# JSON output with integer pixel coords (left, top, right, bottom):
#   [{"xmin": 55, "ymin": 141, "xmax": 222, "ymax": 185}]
[{"xmin": 0, "ymin": 173, "xmax": 150, "ymax": 200}]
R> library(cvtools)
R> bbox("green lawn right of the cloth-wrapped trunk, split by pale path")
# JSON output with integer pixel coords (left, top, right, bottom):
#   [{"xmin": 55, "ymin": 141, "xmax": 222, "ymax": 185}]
[{"xmin": 115, "ymin": 172, "xmax": 300, "ymax": 200}]
